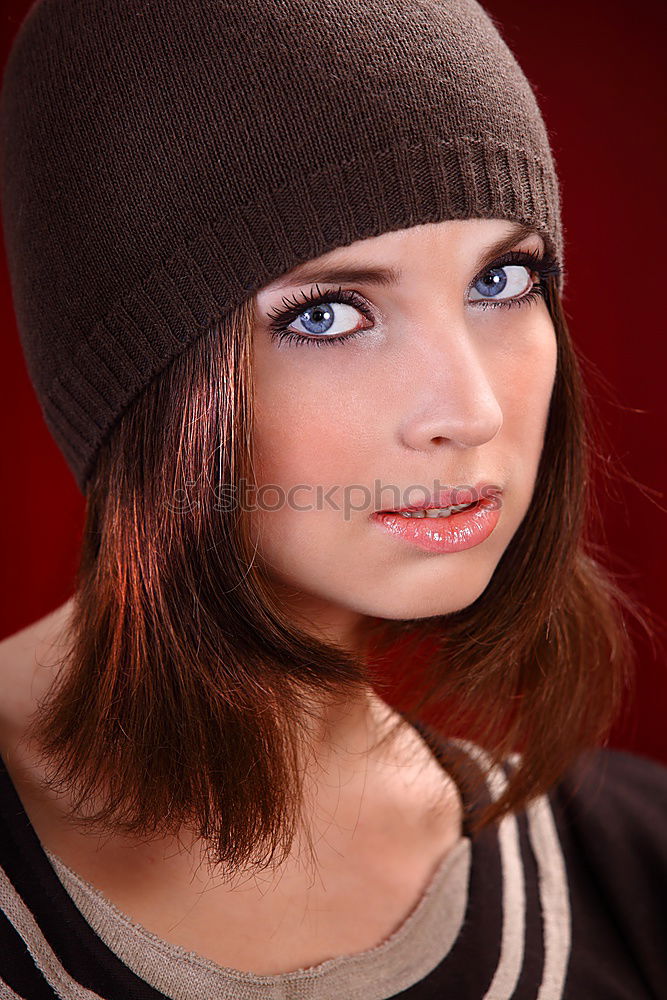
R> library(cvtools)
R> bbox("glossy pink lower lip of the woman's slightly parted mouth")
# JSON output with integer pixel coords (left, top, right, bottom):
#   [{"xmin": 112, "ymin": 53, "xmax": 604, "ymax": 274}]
[{"xmin": 372, "ymin": 499, "xmax": 500, "ymax": 552}]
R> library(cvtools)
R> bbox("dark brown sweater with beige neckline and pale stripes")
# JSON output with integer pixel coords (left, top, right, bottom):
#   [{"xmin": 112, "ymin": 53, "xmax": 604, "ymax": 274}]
[{"xmin": 0, "ymin": 725, "xmax": 667, "ymax": 1000}]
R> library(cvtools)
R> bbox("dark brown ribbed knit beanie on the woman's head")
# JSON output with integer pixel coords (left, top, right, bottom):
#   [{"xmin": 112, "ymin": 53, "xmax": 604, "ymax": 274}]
[{"xmin": 0, "ymin": 0, "xmax": 563, "ymax": 492}]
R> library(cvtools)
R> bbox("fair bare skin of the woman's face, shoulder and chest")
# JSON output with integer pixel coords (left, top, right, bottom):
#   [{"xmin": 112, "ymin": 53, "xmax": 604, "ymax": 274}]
[{"xmin": 0, "ymin": 219, "xmax": 556, "ymax": 975}]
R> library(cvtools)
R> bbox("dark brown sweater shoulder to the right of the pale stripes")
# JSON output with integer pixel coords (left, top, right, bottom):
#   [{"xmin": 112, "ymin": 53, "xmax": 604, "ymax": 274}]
[{"xmin": 547, "ymin": 749, "xmax": 667, "ymax": 997}]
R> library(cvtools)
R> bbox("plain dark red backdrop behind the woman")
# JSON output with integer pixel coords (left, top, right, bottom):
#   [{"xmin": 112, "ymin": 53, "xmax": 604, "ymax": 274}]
[{"xmin": 0, "ymin": 0, "xmax": 667, "ymax": 762}]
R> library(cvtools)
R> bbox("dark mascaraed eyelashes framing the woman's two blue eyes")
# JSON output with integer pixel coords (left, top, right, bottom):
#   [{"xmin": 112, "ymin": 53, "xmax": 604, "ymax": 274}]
[{"xmin": 269, "ymin": 250, "xmax": 560, "ymax": 347}]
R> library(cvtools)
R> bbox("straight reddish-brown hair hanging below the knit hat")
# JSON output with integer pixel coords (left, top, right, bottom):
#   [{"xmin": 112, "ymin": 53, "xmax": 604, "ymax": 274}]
[{"xmin": 24, "ymin": 266, "xmax": 647, "ymax": 868}]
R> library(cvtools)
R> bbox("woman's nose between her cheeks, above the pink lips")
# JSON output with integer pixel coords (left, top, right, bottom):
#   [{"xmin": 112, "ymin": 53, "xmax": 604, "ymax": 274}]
[{"xmin": 400, "ymin": 324, "xmax": 503, "ymax": 451}]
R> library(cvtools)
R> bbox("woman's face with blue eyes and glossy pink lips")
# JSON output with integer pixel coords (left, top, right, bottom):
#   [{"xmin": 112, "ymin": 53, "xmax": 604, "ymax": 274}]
[{"xmin": 251, "ymin": 219, "xmax": 556, "ymax": 641}]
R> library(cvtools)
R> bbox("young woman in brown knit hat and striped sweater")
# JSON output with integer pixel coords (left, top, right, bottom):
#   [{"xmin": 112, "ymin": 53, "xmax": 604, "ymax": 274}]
[{"xmin": 0, "ymin": 0, "xmax": 667, "ymax": 1000}]
